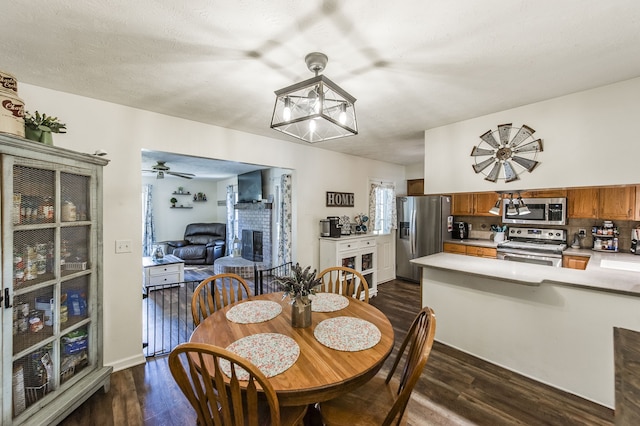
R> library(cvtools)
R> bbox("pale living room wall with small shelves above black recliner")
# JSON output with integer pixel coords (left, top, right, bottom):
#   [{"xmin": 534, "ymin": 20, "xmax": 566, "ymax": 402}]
[{"xmin": 140, "ymin": 175, "xmax": 221, "ymax": 242}]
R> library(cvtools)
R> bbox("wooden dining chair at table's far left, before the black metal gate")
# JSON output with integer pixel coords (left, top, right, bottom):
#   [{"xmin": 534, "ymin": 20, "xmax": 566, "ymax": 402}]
[{"xmin": 191, "ymin": 274, "xmax": 251, "ymax": 326}]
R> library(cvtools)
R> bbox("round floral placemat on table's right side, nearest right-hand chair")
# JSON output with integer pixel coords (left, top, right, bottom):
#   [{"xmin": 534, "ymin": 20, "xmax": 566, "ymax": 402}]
[{"xmin": 313, "ymin": 317, "xmax": 382, "ymax": 352}]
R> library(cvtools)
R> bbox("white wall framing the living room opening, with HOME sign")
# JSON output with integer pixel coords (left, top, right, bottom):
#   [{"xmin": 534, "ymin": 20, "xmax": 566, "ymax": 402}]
[{"xmin": 19, "ymin": 84, "xmax": 405, "ymax": 369}]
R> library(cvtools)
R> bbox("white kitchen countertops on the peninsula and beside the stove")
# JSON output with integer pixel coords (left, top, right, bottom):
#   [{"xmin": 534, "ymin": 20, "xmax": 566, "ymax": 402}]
[{"xmin": 411, "ymin": 250, "xmax": 640, "ymax": 296}]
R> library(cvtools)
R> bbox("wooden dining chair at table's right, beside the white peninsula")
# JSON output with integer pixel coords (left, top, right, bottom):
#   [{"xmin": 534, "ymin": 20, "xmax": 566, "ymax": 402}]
[{"xmin": 318, "ymin": 307, "xmax": 436, "ymax": 426}]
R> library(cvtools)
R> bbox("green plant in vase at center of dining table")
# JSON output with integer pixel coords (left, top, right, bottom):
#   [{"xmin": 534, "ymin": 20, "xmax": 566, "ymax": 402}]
[{"xmin": 275, "ymin": 263, "xmax": 322, "ymax": 328}]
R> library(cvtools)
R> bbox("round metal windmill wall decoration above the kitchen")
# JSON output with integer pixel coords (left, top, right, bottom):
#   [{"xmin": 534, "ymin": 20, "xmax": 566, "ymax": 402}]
[{"xmin": 471, "ymin": 123, "xmax": 542, "ymax": 182}]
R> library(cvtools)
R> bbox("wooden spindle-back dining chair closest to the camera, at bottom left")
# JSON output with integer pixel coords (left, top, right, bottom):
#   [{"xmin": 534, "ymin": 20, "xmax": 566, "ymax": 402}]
[{"xmin": 169, "ymin": 343, "xmax": 307, "ymax": 426}]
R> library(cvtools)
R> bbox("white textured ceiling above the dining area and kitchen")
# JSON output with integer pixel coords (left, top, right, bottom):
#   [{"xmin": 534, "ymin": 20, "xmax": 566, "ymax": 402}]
[{"xmin": 0, "ymin": 0, "xmax": 640, "ymax": 164}]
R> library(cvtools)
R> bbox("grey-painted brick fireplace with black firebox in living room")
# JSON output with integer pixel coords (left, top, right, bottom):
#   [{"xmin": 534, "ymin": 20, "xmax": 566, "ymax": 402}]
[{"xmin": 235, "ymin": 203, "xmax": 273, "ymax": 268}]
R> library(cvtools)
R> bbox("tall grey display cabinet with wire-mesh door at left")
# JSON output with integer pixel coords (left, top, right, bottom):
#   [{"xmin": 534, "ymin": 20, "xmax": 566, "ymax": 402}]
[{"xmin": 0, "ymin": 134, "xmax": 111, "ymax": 425}]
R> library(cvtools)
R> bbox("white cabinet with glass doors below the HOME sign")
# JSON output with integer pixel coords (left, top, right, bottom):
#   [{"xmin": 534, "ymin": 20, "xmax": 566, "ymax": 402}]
[{"xmin": 320, "ymin": 235, "xmax": 378, "ymax": 297}]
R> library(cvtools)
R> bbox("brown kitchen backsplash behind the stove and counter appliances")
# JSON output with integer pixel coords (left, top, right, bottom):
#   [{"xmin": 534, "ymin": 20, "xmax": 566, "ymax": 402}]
[{"xmin": 454, "ymin": 216, "xmax": 640, "ymax": 253}]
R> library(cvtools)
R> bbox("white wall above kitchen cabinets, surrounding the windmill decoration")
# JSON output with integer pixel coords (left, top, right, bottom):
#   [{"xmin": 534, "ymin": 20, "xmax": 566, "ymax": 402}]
[{"xmin": 424, "ymin": 78, "xmax": 640, "ymax": 193}]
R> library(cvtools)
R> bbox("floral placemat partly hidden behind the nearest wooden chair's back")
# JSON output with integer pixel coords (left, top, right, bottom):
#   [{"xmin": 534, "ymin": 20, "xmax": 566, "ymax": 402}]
[{"xmin": 220, "ymin": 333, "xmax": 300, "ymax": 380}]
